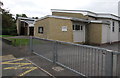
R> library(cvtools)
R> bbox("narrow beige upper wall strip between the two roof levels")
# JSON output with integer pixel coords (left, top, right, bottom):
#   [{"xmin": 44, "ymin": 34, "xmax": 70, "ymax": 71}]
[{"xmin": 52, "ymin": 12, "xmax": 87, "ymax": 19}]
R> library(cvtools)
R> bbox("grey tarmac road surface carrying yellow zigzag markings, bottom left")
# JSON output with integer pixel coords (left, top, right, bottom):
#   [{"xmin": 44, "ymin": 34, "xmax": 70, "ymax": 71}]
[{"xmin": 1, "ymin": 56, "xmax": 49, "ymax": 76}]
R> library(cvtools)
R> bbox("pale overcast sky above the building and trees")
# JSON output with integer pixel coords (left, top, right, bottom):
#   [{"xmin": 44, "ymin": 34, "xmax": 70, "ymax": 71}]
[{"xmin": 1, "ymin": 0, "xmax": 120, "ymax": 17}]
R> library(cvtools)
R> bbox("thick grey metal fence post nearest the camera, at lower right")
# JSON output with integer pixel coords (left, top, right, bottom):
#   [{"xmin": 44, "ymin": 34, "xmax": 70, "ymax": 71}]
[{"xmin": 105, "ymin": 50, "xmax": 113, "ymax": 76}]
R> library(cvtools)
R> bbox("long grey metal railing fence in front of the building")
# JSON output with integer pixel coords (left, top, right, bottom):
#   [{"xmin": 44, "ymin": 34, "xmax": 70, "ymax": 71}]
[{"xmin": 30, "ymin": 37, "xmax": 120, "ymax": 76}]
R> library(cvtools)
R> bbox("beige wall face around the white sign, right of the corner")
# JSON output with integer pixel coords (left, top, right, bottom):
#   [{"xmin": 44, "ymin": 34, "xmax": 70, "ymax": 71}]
[{"xmin": 49, "ymin": 18, "xmax": 73, "ymax": 42}]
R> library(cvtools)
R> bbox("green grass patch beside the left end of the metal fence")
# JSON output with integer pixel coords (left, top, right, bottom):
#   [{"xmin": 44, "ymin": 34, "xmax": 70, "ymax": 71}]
[{"xmin": 8, "ymin": 38, "xmax": 29, "ymax": 46}]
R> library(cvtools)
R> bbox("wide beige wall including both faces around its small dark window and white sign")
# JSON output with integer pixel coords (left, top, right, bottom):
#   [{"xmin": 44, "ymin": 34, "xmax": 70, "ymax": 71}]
[{"xmin": 34, "ymin": 18, "xmax": 73, "ymax": 42}]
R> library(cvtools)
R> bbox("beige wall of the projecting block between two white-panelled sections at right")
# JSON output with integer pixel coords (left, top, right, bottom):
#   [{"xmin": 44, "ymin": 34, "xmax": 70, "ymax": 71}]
[{"xmin": 87, "ymin": 23, "xmax": 102, "ymax": 44}]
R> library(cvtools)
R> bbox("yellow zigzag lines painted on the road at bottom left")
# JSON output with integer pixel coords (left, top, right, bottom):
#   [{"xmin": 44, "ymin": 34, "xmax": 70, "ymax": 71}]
[{"xmin": 0, "ymin": 58, "xmax": 37, "ymax": 76}]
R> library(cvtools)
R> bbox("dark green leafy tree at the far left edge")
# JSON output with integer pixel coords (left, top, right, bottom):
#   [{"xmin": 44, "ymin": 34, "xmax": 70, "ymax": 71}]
[{"xmin": 2, "ymin": 9, "xmax": 17, "ymax": 35}]
